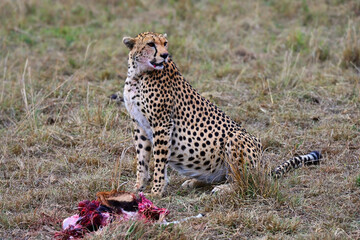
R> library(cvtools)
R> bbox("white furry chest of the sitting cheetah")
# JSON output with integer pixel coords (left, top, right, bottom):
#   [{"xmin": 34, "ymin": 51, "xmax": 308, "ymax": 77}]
[{"xmin": 124, "ymin": 78, "xmax": 153, "ymax": 142}]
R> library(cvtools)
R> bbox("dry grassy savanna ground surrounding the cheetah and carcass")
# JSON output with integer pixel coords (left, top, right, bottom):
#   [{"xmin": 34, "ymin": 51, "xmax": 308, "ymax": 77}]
[{"xmin": 0, "ymin": 0, "xmax": 360, "ymax": 239}]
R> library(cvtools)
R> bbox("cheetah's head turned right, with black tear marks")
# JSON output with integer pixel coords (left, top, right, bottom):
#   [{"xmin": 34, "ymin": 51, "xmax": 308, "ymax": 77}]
[{"xmin": 123, "ymin": 32, "xmax": 169, "ymax": 71}]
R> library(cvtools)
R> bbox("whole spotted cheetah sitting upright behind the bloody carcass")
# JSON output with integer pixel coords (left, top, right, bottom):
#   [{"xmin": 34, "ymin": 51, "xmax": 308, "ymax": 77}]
[{"xmin": 123, "ymin": 32, "xmax": 321, "ymax": 196}]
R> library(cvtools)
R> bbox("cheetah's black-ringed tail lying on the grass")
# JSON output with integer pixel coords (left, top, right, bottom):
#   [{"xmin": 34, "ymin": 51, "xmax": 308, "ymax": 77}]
[{"xmin": 272, "ymin": 151, "xmax": 322, "ymax": 178}]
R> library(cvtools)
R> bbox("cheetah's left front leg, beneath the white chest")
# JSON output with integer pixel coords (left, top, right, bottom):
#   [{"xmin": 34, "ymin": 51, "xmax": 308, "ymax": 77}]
[{"xmin": 134, "ymin": 126, "xmax": 151, "ymax": 191}]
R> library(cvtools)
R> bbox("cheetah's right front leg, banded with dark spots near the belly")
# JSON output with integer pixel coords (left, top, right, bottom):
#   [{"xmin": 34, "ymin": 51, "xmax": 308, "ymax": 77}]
[{"xmin": 151, "ymin": 124, "xmax": 172, "ymax": 196}]
